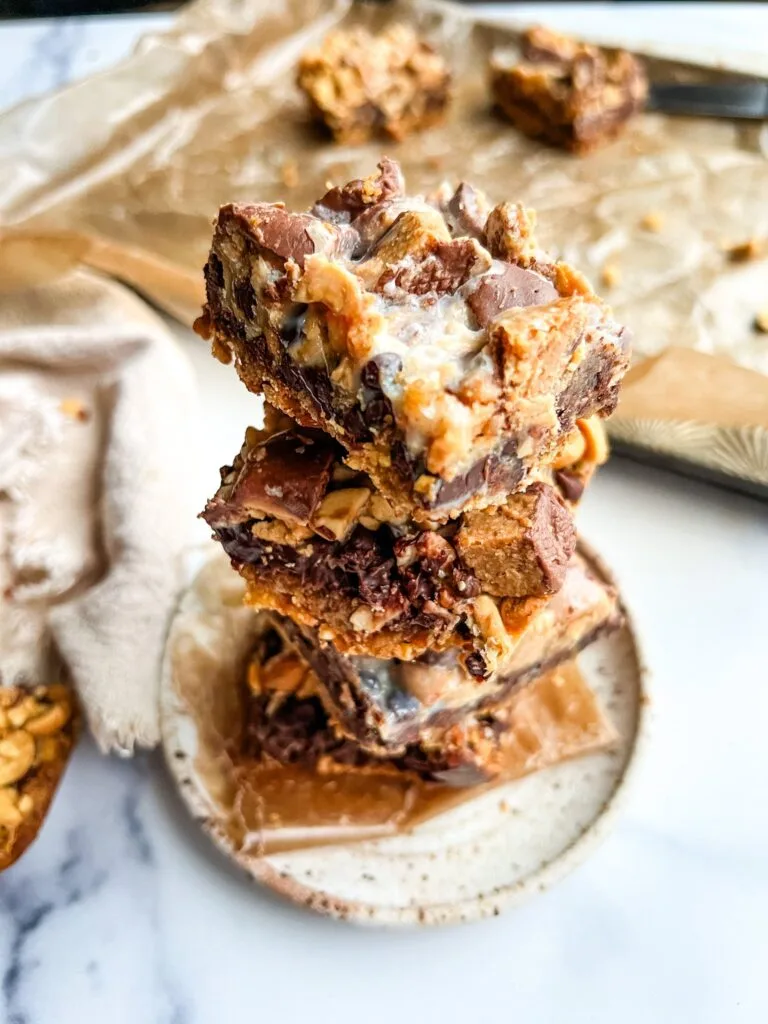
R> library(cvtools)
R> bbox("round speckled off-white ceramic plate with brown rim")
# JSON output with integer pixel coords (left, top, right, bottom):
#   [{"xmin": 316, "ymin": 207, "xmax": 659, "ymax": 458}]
[{"xmin": 162, "ymin": 550, "xmax": 646, "ymax": 925}]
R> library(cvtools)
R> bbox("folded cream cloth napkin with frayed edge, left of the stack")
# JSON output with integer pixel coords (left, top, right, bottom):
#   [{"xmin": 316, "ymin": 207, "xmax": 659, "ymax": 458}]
[{"xmin": 0, "ymin": 262, "xmax": 197, "ymax": 753}]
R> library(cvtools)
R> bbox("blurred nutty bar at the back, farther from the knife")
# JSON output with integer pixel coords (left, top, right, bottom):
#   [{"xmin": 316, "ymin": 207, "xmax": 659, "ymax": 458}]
[{"xmin": 297, "ymin": 25, "xmax": 451, "ymax": 144}]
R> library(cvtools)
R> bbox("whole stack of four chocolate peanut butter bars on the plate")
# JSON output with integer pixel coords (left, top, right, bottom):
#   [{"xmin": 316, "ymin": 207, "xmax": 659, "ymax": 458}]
[{"xmin": 196, "ymin": 159, "xmax": 630, "ymax": 785}]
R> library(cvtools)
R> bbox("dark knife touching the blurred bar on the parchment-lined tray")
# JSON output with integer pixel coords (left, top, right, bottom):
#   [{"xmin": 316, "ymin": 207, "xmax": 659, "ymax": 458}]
[{"xmin": 647, "ymin": 81, "xmax": 768, "ymax": 121}]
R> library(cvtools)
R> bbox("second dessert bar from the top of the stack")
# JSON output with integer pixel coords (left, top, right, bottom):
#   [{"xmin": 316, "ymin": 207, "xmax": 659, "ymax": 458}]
[{"xmin": 203, "ymin": 409, "xmax": 604, "ymax": 677}]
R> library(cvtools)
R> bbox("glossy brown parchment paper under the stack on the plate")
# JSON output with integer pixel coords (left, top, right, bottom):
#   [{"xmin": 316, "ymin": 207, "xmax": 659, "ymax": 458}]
[{"xmin": 230, "ymin": 663, "xmax": 615, "ymax": 853}]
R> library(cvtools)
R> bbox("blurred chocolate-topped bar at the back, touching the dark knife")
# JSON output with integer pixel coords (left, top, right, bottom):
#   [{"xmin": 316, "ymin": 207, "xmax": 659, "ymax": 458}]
[{"xmin": 490, "ymin": 28, "xmax": 648, "ymax": 154}]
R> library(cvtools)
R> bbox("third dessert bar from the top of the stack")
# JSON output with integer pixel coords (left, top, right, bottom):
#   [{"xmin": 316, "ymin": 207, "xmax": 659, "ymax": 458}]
[{"xmin": 275, "ymin": 558, "xmax": 622, "ymax": 757}]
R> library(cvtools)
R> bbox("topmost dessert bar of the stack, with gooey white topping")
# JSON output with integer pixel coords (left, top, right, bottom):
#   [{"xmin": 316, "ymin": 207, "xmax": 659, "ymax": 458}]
[{"xmin": 197, "ymin": 159, "xmax": 630, "ymax": 523}]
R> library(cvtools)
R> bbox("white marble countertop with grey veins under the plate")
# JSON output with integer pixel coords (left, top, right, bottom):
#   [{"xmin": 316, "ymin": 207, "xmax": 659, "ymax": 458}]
[{"xmin": 0, "ymin": 4, "xmax": 768, "ymax": 1024}]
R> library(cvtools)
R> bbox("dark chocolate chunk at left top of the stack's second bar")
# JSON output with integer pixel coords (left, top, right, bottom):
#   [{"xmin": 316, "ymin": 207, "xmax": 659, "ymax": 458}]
[{"xmin": 203, "ymin": 433, "xmax": 336, "ymax": 525}]
